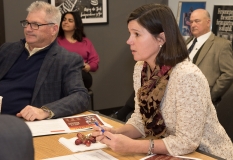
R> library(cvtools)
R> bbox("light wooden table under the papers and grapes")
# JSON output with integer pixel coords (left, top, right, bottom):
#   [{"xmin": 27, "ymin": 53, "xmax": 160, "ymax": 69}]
[{"xmin": 33, "ymin": 112, "xmax": 216, "ymax": 160}]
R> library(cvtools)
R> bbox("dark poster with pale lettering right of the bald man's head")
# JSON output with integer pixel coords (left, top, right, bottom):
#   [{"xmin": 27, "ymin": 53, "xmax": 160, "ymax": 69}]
[{"xmin": 212, "ymin": 5, "xmax": 233, "ymax": 46}]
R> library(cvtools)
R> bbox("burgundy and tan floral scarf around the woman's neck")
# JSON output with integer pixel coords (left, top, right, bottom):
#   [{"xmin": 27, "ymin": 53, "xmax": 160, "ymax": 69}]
[{"xmin": 137, "ymin": 62, "xmax": 172, "ymax": 137}]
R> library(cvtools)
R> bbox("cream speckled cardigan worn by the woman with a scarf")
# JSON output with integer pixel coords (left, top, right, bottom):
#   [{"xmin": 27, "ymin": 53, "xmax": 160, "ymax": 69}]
[{"xmin": 127, "ymin": 60, "xmax": 233, "ymax": 160}]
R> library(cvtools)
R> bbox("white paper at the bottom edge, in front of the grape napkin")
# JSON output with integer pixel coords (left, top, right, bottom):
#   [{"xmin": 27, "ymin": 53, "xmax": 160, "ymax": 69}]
[{"xmin": 44, "ymin": 150, "xmax": 118, "ymax": 160}]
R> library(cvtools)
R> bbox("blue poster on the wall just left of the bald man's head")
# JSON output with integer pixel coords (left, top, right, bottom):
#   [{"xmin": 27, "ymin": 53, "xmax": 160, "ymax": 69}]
[{"xmin": 176, "ymin": 1, "xmax": 206, "ymax": 39}]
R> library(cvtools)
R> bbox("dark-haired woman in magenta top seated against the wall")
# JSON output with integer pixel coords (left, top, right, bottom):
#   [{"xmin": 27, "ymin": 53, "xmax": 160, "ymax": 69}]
[{"xmin": 57, "ymin": 12, "xmax": 99, "ymax": 89}]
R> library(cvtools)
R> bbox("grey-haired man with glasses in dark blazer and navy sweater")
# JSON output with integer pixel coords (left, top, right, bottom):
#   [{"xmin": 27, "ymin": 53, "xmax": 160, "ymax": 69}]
[{"xmin": 0, "ymin": 1, "xmax": 90, "ymax": 121}]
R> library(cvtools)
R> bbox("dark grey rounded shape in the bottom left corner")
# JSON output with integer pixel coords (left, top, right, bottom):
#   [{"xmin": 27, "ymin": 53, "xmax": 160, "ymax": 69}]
[{"xmin": 0, "ymin": 115, "xmax": 34, "ymax": 160}]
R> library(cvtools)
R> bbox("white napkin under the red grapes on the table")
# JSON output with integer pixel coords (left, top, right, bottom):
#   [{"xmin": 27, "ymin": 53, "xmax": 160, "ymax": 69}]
[{"xmin": 58, "ymin": 137, "xmax": 108, "ymax": 152}]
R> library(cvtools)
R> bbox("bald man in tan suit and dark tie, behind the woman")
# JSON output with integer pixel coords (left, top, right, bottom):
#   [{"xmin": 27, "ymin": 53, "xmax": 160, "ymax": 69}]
[{"xmin": 187, "ymin": 9, "xmax": 233, "ymax": 106}]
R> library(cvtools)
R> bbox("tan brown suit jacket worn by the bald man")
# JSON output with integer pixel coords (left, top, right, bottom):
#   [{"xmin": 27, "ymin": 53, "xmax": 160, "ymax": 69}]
[{"xmin": 186, "ymin": 33, "xmax": 233, "ymax": 102}]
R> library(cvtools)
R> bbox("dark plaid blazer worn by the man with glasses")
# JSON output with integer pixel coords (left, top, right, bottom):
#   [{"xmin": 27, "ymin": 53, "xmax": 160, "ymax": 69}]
[{"xmin": 0, "ymin": 41, "xmax": 90, "ymax": 118}]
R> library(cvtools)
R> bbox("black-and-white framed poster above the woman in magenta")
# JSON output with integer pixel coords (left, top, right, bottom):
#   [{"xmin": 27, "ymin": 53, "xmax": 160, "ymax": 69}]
[{"xmin": 49, "ymin": 0, "xmax": 108, "ymax": 24}]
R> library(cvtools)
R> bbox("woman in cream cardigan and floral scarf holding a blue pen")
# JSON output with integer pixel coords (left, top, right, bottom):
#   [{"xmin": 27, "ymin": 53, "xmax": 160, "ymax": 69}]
[{"xmin": 92, "ymin": 4, "xmax": 233, "ymax": 160}]
